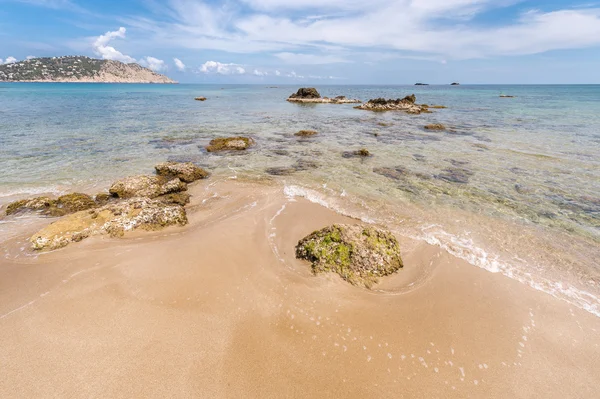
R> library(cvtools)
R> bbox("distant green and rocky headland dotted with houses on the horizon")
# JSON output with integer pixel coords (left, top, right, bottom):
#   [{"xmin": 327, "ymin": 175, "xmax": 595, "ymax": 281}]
[{"xmin": 0, "ymin": 56, "xmax": 177, "ymax": 83}]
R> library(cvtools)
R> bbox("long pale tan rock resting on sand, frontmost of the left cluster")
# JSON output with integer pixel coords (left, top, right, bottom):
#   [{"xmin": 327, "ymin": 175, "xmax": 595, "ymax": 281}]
[{"xmin": 30, "ymin": 198, "xmax": 187, "ymax": 250}]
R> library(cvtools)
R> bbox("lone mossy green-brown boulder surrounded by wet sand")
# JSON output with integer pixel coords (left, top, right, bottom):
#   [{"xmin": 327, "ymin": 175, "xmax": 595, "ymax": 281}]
[{"xmin": 296, "ymin": 224, "xmax": 403, "ymax": 288}]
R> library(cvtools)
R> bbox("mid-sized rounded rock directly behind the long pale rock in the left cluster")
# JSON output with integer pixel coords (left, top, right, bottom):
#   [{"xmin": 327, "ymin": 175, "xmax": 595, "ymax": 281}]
[{"xmin": 108, "ymin": 175, "xmax": 187, "ymax": 198}]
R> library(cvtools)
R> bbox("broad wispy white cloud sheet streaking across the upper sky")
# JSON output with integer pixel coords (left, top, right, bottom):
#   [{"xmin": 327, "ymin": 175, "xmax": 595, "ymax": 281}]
[{"xmin": 119, "ymin": 0, "xmax": 600, "ymax": 60}]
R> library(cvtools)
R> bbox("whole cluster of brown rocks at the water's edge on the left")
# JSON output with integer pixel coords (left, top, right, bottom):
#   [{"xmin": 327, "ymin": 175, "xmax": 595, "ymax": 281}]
[{"xmin": 6, "ymin": 162, "xmax": 208, "ymax": 250}]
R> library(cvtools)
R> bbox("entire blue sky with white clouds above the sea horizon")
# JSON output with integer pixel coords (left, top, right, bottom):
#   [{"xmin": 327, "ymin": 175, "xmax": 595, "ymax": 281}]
[{"xmin": 0, "ymin": 0, "xmax": 600, "ymax": 85}]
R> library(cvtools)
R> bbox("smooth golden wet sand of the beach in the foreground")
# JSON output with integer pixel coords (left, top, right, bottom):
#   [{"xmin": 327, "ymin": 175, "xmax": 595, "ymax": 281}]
[{"xmin": 0, "ymin": 181, "xmax": 600, "ymax": 398}]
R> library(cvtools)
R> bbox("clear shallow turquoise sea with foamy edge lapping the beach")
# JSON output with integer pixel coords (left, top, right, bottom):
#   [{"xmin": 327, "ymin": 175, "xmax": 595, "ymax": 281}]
[{"xmin": 0, "ymin": 83, "xmax": 600, "ymax": 315}]
